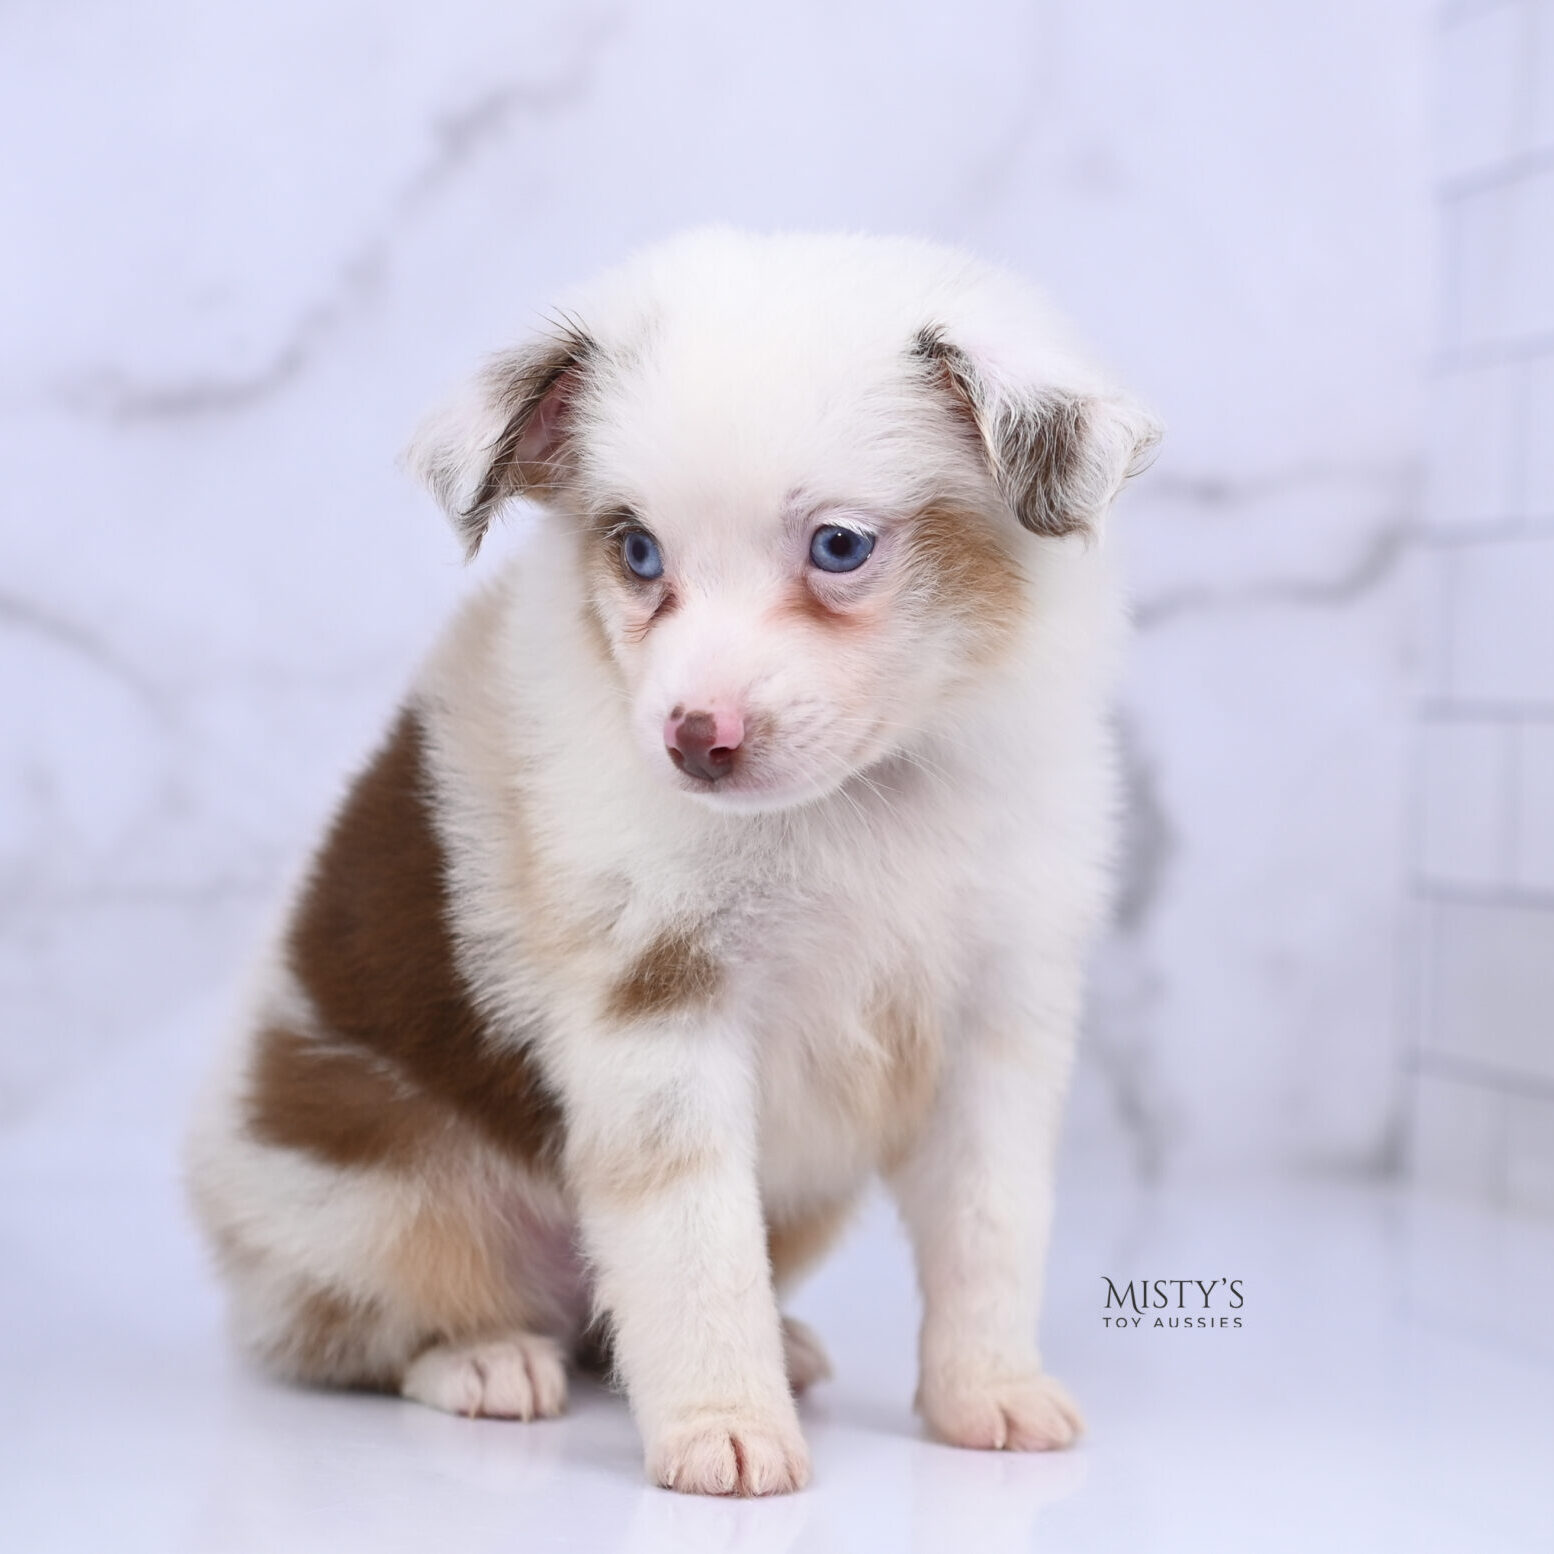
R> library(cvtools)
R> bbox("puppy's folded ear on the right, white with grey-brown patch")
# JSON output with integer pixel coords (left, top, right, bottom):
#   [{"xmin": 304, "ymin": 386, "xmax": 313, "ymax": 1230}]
[{"xmin": 912, "ymin": 325, "xmax": 1161, "ymax": 535}]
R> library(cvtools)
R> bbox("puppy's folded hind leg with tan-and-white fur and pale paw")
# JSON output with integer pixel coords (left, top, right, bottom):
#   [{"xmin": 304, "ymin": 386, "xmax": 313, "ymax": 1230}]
[{"xmin": 194, "ymin": 1112, "xmax": 587, "ymax": 1419}]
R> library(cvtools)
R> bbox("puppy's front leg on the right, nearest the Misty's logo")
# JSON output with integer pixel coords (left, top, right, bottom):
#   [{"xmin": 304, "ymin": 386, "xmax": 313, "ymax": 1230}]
[{"xmin": 892, "ymin": 968, "xmax": 1083, "ymax": 1451}]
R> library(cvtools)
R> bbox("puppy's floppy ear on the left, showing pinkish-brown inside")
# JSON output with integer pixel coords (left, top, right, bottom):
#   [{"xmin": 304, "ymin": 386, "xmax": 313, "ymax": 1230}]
[{"xmin": 406, "ymin": 325, "xmax": 598, "ymax": 559}]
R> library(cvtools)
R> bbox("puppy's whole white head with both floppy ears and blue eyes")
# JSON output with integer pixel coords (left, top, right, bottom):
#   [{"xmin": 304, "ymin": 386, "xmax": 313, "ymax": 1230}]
[{"xmin": 412, "ymin": 232, "xmax": 1156, "ymax": 808}]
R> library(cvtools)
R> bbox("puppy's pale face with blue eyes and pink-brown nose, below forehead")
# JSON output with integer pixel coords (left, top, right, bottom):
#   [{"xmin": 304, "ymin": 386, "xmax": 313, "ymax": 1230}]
[{"xmin": 583, "ymin": 485, "xmax": 1024, "ymax": 808}]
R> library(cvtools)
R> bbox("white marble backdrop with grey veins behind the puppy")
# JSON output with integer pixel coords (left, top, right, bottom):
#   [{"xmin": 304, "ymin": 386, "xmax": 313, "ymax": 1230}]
[{"xmin": 0, "ymin": 0, "xmax": 1431, "ymax": 1173}]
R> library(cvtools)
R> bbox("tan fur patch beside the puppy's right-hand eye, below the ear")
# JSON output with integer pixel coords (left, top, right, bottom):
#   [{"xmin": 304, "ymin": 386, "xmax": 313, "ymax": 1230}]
[{"xmin": 906, "ymin": 502, "xmax": 1026, "ymax": 660}]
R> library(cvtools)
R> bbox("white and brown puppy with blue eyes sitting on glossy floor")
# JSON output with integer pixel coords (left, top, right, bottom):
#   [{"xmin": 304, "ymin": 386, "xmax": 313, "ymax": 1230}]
[{"xmin": 191, "ymin": 230, "xmax": 1156, "ymax": 1495}]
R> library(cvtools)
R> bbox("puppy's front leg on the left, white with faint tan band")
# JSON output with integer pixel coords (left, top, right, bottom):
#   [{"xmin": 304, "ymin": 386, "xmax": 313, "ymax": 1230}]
[{"xmin": 567, "ymin": 1024, "xmax": 810, "ymax": 1495}]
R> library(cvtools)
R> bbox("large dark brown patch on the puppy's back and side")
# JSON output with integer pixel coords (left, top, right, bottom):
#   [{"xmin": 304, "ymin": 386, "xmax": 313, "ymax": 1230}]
[{"xmin": 250, "ymin": 709, "xmax": 563, "ymax": 1167}]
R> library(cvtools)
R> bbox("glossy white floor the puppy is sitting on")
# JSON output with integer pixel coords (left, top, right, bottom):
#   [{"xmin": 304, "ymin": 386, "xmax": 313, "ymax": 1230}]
[{"xmin": 0, "ymin": 1013, "xmax": 1554, "ymax": 1554}]
